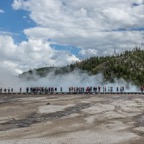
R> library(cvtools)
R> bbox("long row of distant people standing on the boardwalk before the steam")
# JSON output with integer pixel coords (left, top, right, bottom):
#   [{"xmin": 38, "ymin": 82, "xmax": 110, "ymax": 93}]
[{"xmin": 0, "ymin": 86, "xmax": 125, "ymax": 94}]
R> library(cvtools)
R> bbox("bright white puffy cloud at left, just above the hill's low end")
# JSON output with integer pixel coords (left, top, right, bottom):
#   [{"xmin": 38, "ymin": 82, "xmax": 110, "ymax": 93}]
[{"xmin": 0, "ymin": 36, "xmax": 79, "ymax": 73}]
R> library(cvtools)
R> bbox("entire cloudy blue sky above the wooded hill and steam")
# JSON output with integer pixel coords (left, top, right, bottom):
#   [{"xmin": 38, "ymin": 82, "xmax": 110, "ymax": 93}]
[{"xmin": 0, "ymin": 0, "xmax": 144, "ymax": 73}]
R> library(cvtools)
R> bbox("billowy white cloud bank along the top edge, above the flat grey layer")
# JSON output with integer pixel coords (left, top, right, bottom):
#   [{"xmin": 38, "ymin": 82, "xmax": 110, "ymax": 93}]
[{"xmin": 13, "ymin": 0, "xmax": 144, "ymax": 31}]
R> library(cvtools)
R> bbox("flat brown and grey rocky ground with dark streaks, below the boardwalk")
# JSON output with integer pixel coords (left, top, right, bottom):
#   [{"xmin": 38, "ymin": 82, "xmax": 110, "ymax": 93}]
[{"xmin": 0, "ymin": 94, "xmax": 144, "ymax": 144}]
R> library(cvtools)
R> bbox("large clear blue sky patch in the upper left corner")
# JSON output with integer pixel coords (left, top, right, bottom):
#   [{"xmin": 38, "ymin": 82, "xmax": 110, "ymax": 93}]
[{"xmin": 0, "ymin": 0, "xmax": 36, "ymax": 43}]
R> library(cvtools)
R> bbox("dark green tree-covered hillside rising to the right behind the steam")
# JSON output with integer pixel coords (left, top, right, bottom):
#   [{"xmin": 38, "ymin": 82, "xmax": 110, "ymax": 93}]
[{"xmin": 21, "ymin": 48, "xmax": 144, "ymax": 85}]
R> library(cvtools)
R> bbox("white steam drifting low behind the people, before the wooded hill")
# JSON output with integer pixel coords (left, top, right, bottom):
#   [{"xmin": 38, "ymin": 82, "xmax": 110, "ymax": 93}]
[{"xmin": 0, "ymin": 67, "xmax": 139, "ymax": 92}]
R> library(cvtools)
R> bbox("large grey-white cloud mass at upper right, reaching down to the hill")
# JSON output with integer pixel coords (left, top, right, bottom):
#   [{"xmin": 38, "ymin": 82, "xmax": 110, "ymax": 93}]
[{"xmin": 13, "ymin": 0, "xmax": 144, "ymax": 56}]
